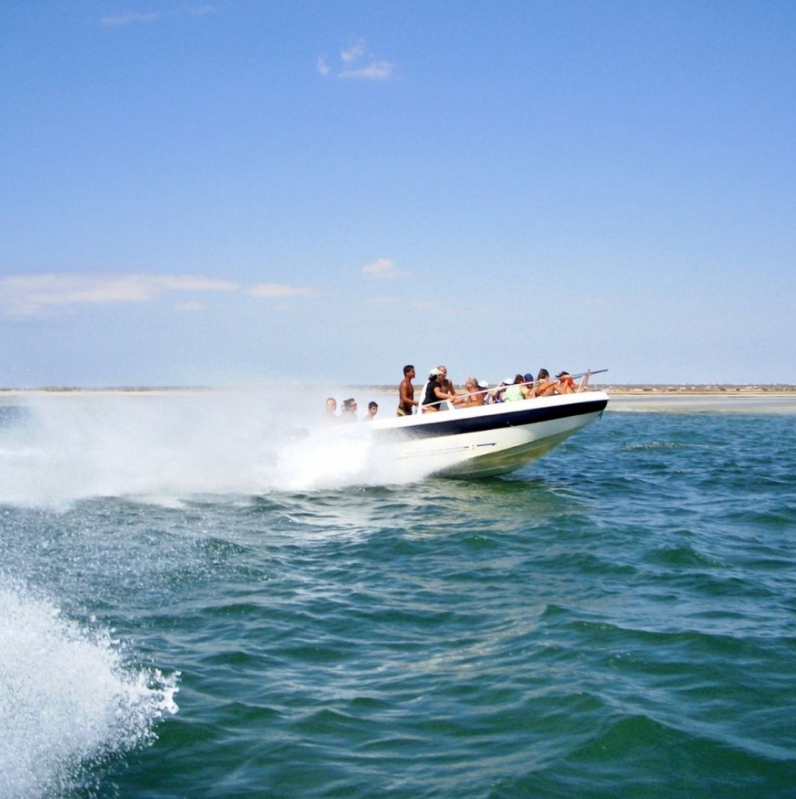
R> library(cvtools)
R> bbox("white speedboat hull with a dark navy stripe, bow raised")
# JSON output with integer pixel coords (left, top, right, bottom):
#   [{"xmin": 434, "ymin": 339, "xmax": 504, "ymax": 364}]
[{"xmin": 368, "ymin": 391, "xmax": 608, "ymax": 478}]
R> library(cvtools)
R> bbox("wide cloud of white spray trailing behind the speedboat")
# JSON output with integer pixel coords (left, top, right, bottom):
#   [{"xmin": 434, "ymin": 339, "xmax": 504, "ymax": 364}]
[{"xmin": 0, "ymin": 391, "xmax": 430, "ymax": 507}]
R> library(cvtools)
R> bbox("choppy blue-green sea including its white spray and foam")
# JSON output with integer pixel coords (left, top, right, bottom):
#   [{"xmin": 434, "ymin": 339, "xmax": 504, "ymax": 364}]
[{"xmin": 0, "ymin": 393, "xmax": 796, "ymax": 799}]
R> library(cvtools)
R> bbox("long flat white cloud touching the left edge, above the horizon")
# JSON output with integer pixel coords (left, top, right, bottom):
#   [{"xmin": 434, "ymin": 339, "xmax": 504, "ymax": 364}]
[{"xmin": 0, "ymin": 274, "xmax": 238, "ymax": 316}]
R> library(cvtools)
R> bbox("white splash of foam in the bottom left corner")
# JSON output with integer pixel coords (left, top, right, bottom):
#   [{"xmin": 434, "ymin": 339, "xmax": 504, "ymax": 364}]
[{"xmin": 0, "ymin": 580, "xmax": 177, "ymax": 799}]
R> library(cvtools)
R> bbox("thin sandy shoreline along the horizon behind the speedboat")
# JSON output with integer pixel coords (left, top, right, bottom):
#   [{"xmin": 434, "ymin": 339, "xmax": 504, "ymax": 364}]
[{"xmin": 0, "ymin": 384, "xmax": 796, "ymax": 398}]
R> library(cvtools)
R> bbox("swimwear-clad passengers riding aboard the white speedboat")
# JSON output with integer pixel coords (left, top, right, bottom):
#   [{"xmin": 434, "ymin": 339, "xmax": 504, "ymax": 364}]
[{"xmin": 321, "ymin": 364, "xmax": 591, "ymax": 424}]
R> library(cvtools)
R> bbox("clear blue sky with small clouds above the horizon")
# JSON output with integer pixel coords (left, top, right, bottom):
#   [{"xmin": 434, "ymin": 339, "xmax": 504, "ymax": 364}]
[{"xmin": 0, "ymin": 0, "xmax": 796, "ymax": 387}]
